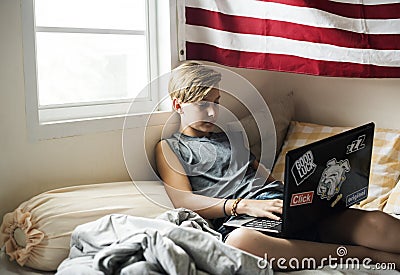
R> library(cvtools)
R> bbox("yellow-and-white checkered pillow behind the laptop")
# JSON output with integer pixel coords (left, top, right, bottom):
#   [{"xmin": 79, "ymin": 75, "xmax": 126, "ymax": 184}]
[{"xmin": 272, "ymin": 121, "xmax": 400, "ymax": 210}]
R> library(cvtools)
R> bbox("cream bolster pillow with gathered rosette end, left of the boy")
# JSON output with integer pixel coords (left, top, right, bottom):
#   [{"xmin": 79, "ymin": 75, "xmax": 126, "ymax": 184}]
[{"xmin": 0, "ymin": 182, "xmax": 172, "ymax": 271}]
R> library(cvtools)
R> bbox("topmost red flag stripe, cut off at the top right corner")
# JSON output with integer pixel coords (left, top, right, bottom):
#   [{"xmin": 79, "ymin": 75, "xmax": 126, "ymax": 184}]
[{"xmin": 258, "ymin": 0, "xmax": 400, "ymax": 19}]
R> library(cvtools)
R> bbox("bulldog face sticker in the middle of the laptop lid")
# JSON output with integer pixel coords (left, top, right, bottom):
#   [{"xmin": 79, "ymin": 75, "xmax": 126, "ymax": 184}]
[{"xmin": 317, "ymin": 158, "xmax": 350, "ymax": 200}]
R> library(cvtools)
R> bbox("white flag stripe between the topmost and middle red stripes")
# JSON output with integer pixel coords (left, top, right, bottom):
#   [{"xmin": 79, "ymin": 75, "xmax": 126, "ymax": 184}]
[{"xmin": 186, "ymin": 0, "xmax": 400, "ymax": 34}]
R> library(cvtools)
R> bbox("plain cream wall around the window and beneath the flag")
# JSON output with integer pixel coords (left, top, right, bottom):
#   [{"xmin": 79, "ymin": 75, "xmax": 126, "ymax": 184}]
[{"xmin": 0, "ymin": 0, "xmax": 400, "ymax": 220}]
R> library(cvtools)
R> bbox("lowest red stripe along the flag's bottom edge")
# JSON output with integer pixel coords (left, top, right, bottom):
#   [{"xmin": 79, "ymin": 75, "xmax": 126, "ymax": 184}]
[{"xmin": 186, "ymin": 42, "xmax": 400, "ymax": 78}]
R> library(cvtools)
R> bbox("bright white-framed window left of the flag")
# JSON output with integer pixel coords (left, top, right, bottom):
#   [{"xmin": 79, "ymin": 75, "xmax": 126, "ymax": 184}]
[{"xmin": 22, "ymin": 0, "xmax": 170, "ymax": 138}]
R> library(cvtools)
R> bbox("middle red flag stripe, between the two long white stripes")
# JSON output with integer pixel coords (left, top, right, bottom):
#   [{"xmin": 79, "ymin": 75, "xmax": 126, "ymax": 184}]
[{"xmin": 186, "ymin": 7, "xmax": 400, "ymax": 50}]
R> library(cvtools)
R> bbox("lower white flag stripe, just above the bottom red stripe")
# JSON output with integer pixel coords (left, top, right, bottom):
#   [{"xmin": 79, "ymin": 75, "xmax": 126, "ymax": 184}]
[{"xmin": 186, "ymin": 25, "xmax": 400, "ymax": 67}]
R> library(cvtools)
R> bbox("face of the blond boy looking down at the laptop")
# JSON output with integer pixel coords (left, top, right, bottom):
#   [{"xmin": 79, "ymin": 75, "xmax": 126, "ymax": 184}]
[{"xmin": 180, "ymin": 88, "xmax": 221, "ymax": 136}]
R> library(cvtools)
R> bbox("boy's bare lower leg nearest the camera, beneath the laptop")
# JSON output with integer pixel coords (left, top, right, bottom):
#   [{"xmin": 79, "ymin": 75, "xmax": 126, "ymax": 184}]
[{"xmin": 226, "ymin": 228, "xmax": 400, "ymax": 270}]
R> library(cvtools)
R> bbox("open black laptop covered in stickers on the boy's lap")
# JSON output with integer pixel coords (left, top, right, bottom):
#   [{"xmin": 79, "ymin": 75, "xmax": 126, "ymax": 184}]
[{"xmin": 224, "ymin": 122, "xmax": 375, "ymax": 238}]
